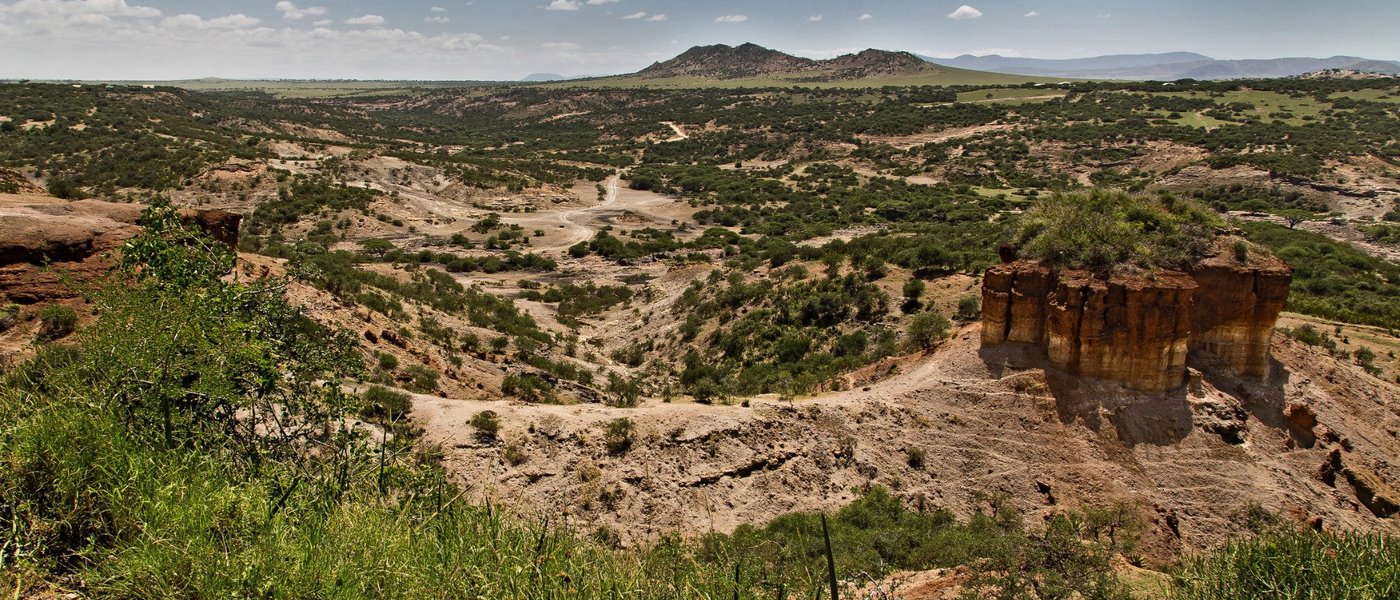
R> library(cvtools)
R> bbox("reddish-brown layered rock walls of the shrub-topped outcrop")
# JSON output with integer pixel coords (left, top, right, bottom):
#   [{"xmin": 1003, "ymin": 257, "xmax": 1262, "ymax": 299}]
[{"xmin": 981, "ymin": 255, "xmax": 1292, "ymax": 392}]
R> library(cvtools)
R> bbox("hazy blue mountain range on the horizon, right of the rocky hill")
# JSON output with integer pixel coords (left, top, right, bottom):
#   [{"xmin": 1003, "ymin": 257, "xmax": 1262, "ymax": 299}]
[{"xmin": 921, "ymin": 52, "xmax": 1400, "ymax": 81}]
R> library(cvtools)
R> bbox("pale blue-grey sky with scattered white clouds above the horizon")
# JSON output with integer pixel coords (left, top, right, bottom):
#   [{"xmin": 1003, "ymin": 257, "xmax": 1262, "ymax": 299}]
[{"xmin": 0, "ymin": 0, "xmax": 1400, "ymax": 80}]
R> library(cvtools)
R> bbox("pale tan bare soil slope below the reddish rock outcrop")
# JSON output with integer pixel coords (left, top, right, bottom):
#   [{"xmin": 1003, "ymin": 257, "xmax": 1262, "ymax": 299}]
[{"xmin": 414, "ymin": 324, "xmax": 1400, "ymax": 558}]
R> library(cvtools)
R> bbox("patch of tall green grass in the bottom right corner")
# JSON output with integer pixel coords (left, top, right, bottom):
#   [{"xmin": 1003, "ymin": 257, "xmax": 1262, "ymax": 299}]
[{"xmin": 1173, "ymin": 530, "xmax": 1400, "ymax": 600}]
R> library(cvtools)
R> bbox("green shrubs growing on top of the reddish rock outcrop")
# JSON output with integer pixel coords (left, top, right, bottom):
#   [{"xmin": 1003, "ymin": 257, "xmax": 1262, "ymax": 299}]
[{"xmin": 1015, "ymin": 189, "xmax": 1224, "ymax": 269}]
